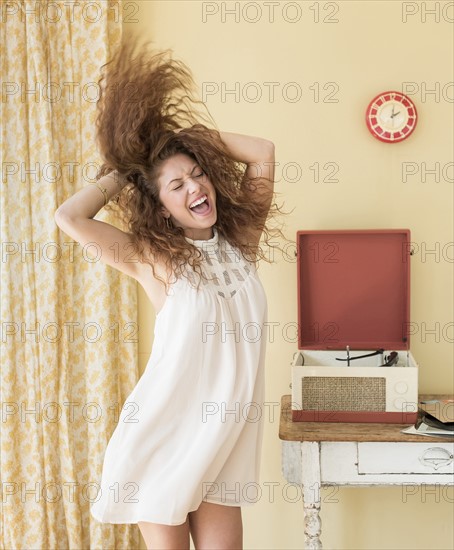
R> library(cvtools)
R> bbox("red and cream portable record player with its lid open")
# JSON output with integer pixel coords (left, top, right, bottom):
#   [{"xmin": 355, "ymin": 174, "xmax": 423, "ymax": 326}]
[{"xmin": 292, "ymin": 229, "xmax": 418, "ymax": 424}]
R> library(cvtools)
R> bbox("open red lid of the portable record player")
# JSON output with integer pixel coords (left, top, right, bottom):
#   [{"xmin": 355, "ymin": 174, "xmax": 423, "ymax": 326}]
[{"xmin": 296, "ymin": 229, "xmax": 410, "ymax": 350}]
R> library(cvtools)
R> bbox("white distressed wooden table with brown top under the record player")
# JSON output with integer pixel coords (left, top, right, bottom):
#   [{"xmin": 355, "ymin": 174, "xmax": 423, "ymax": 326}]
[{"xmin": 279, "ymin": 395, "xmax": 454, "ymax": 549}]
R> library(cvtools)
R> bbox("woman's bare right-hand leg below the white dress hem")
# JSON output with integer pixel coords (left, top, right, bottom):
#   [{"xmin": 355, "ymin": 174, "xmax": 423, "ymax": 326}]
[{"xmin": 188, "ymin": 501, "xmax": 243, "ymax": 550}]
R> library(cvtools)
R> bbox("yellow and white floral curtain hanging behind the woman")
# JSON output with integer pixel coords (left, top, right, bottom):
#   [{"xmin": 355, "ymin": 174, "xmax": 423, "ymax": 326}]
[{"xmin": 0, "ymin": 0, "xmax": 139, "ymax": 550}]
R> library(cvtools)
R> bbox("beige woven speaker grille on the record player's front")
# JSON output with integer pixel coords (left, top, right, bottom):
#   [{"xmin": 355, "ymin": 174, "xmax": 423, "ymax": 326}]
[{"xmin": 302, "ymin": 376, "xmax": 386, "ymax": 412}]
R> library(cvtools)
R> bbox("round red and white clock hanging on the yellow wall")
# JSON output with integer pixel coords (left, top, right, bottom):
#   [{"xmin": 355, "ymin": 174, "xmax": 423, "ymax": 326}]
[{"xmin": 366, "ymin": 92, "xmax": 418, "ymax": 143}]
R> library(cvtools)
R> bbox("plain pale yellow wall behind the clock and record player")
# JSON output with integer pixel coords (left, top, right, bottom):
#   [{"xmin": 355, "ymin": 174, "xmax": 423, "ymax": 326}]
[{"xmin": 124, "ymin": 1, "xmax": 454, "ymax": 549}]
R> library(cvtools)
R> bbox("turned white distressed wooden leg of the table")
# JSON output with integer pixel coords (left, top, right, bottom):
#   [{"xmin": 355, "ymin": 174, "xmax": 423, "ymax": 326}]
[{"xmin": 302, "ymin": 441, "xmax": 323, "ymax": 550}]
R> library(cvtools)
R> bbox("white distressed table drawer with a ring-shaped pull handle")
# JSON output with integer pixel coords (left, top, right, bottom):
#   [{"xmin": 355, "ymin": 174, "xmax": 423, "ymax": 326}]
[{"xmin": 358, "ymin": 442, "xmax": 454, "ymax": 475}]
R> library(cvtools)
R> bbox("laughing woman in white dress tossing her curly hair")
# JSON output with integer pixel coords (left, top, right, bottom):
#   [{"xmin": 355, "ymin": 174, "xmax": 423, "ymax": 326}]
[{"xmin": 55, "ymin": 40, "xmax": 282, "ymax": 550}]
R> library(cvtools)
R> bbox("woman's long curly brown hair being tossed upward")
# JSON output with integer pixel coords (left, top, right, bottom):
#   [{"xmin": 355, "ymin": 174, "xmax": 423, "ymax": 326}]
[{"xmin": 96, "ymin": 40, "xmax": 285, "ymax": 294}]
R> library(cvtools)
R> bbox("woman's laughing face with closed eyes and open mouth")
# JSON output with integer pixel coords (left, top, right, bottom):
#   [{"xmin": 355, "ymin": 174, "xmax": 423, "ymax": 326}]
[{"xmin": 158, "ymin": 153, "xmax": 217, "ymax": 240}]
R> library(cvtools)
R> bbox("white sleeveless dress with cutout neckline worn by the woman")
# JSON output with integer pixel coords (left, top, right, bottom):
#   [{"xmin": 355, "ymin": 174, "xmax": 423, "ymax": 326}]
[{"xmin": 90, "ymin": 227, "xmax": 267, "ymax": 525}]
